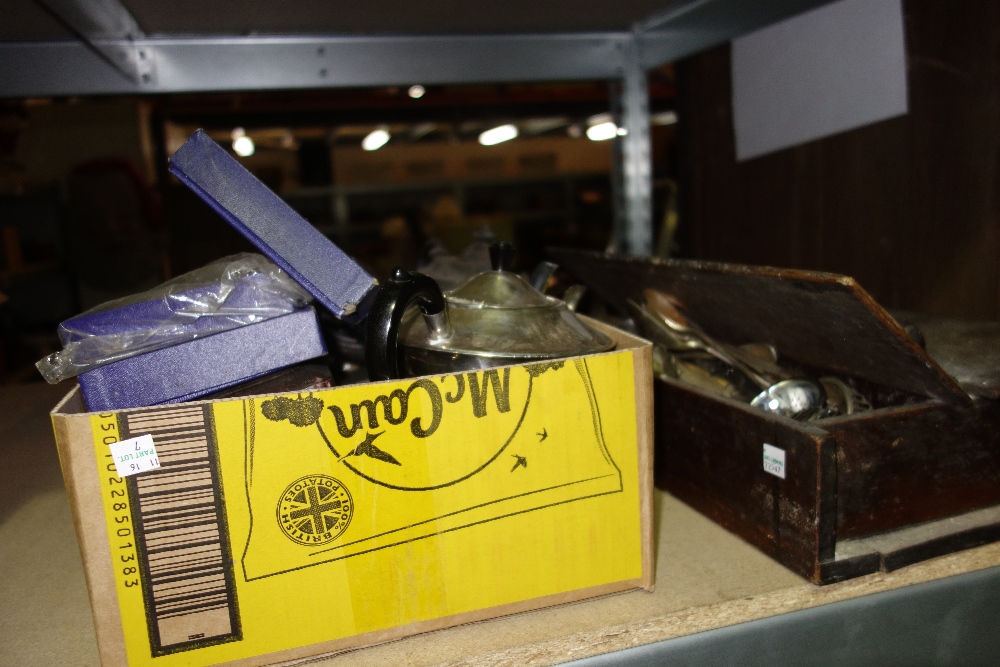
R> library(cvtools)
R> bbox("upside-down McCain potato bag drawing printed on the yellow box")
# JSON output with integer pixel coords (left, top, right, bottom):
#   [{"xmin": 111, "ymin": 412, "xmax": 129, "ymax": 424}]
[{"xmin": 243, "ymin": 359, "xmax": 632, "ymax": 579}]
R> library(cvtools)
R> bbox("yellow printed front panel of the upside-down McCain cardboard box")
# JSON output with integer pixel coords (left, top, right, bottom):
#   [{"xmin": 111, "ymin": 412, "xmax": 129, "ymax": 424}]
[{"xmin": 92, "ymin": 351, "xmax": 642, "ymax": 665}]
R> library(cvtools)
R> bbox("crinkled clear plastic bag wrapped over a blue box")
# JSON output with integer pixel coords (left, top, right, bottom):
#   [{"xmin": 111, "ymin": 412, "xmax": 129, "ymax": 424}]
[{"xmin": 35, "ymin": 253, "xmax": 312, "ymax": 384}]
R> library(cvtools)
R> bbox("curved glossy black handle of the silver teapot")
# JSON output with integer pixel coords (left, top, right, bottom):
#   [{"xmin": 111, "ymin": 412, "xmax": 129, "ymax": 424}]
[{"xmin": 365, "ymin": 269, "xmax": 447, "ymax": 382}]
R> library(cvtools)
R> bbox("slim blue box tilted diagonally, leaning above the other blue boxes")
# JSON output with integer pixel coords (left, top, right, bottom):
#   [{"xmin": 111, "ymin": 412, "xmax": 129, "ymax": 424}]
[{"xmin": 170, "ymin": 130, "xmax": 378, "ymax": 321}]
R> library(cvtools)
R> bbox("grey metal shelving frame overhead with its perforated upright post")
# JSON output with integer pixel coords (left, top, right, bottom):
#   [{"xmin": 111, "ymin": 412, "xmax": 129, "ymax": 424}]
[{"xmin": 0, "ymin": 0, "xmax": 829, "ymax": 255}]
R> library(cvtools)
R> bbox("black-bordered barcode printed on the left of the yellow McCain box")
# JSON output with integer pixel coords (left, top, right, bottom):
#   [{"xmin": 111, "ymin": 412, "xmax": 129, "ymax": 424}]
[{"xmin": 118, "ymin": 406, "xmax": 242, "ymax": 656}]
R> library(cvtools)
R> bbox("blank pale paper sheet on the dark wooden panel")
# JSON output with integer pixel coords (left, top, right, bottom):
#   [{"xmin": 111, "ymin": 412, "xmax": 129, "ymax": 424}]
[{"xmin": 732, "ymin": 0, "xmax": 907, "ymax": 161}]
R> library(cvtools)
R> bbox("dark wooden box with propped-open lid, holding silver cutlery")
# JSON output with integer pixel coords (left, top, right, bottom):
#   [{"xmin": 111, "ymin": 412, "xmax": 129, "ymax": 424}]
[{"xmin": 553, "ymin": 250, "xmax": 1000, "ymax": 584}]
